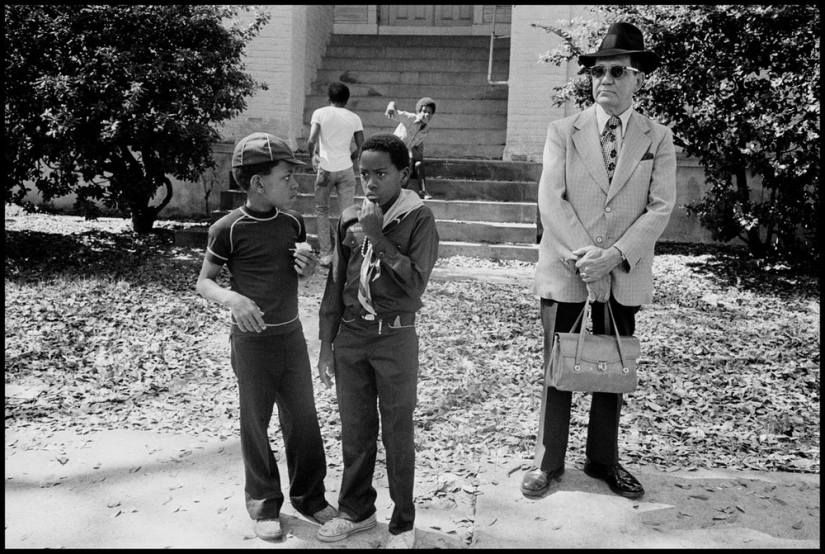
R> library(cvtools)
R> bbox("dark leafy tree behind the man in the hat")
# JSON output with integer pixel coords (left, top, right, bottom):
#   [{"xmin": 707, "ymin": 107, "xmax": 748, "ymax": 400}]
[{"xmin": 535, "ymin": 5, "xmax": 820, "ymax": 264}]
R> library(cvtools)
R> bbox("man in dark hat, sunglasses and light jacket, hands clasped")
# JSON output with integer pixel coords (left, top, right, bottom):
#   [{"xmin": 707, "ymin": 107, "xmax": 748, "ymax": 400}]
[{"xmin": 521, "ymin": 23, "xmax": 676, "ymax": 498}]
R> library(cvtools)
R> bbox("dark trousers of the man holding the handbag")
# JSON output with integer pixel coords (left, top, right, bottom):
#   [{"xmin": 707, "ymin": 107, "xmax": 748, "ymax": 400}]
[{"xmin": 534, "ymin": 297, "xmax": 639, "ymax": 472}]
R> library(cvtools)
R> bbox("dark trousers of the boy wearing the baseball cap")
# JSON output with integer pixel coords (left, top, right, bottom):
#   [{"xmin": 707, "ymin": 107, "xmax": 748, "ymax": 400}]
[{"xmin": 231, "ymin": 328, "xmax": 327, "ymax": 519}]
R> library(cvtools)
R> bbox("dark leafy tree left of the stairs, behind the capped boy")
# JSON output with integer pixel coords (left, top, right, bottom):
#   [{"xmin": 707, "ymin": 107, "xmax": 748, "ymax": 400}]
[{"xmin": 5, "ymin": 5, "xmax": 269, "ymax": 233}]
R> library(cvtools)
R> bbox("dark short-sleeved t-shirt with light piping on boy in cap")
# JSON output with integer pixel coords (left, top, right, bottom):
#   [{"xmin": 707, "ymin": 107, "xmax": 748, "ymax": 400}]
[{"xmin": 206, "ymin": 206, "xmax": 306, "ymax": 335}]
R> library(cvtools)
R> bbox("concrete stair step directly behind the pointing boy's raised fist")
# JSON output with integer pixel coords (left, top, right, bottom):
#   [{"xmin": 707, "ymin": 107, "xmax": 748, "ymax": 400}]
[{"xmin": 306, "ymin": 93, "xmax": 507, "ymax": 115}]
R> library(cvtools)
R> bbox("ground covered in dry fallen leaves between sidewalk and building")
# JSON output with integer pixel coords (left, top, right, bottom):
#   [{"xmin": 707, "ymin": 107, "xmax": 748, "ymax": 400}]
[{"xmin": 5, "ymin": 209, "xmax": 820, "ymax": 486}]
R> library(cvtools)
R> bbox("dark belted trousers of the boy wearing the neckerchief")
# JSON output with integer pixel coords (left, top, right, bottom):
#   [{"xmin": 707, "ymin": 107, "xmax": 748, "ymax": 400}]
[{"xmin": 334, "ymin": 317, "xmax": 418, "ymax": 535}]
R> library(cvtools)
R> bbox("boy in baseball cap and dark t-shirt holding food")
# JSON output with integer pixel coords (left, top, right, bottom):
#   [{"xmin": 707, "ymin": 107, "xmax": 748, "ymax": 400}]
[{"xmin": 197, "ymin": 133, "xmax": 338, "ymax": 540}]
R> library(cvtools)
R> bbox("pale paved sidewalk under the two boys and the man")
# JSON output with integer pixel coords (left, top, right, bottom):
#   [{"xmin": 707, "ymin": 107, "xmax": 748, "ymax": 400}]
[{"xmin": 5, "ymin": 268, "xmax": 820, "ymax": 549}]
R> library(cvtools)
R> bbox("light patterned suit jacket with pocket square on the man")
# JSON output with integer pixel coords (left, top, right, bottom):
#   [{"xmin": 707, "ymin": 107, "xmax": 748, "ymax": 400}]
[{"xmin": 534, "ymin": 105, "xmax": 676, "ymax": 306}]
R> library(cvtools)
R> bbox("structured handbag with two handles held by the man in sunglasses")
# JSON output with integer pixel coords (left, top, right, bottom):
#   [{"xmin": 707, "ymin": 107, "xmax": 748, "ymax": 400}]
[{"xmin": 545, "ymin": 301, "xmax": 641, "ymax": 393}]
